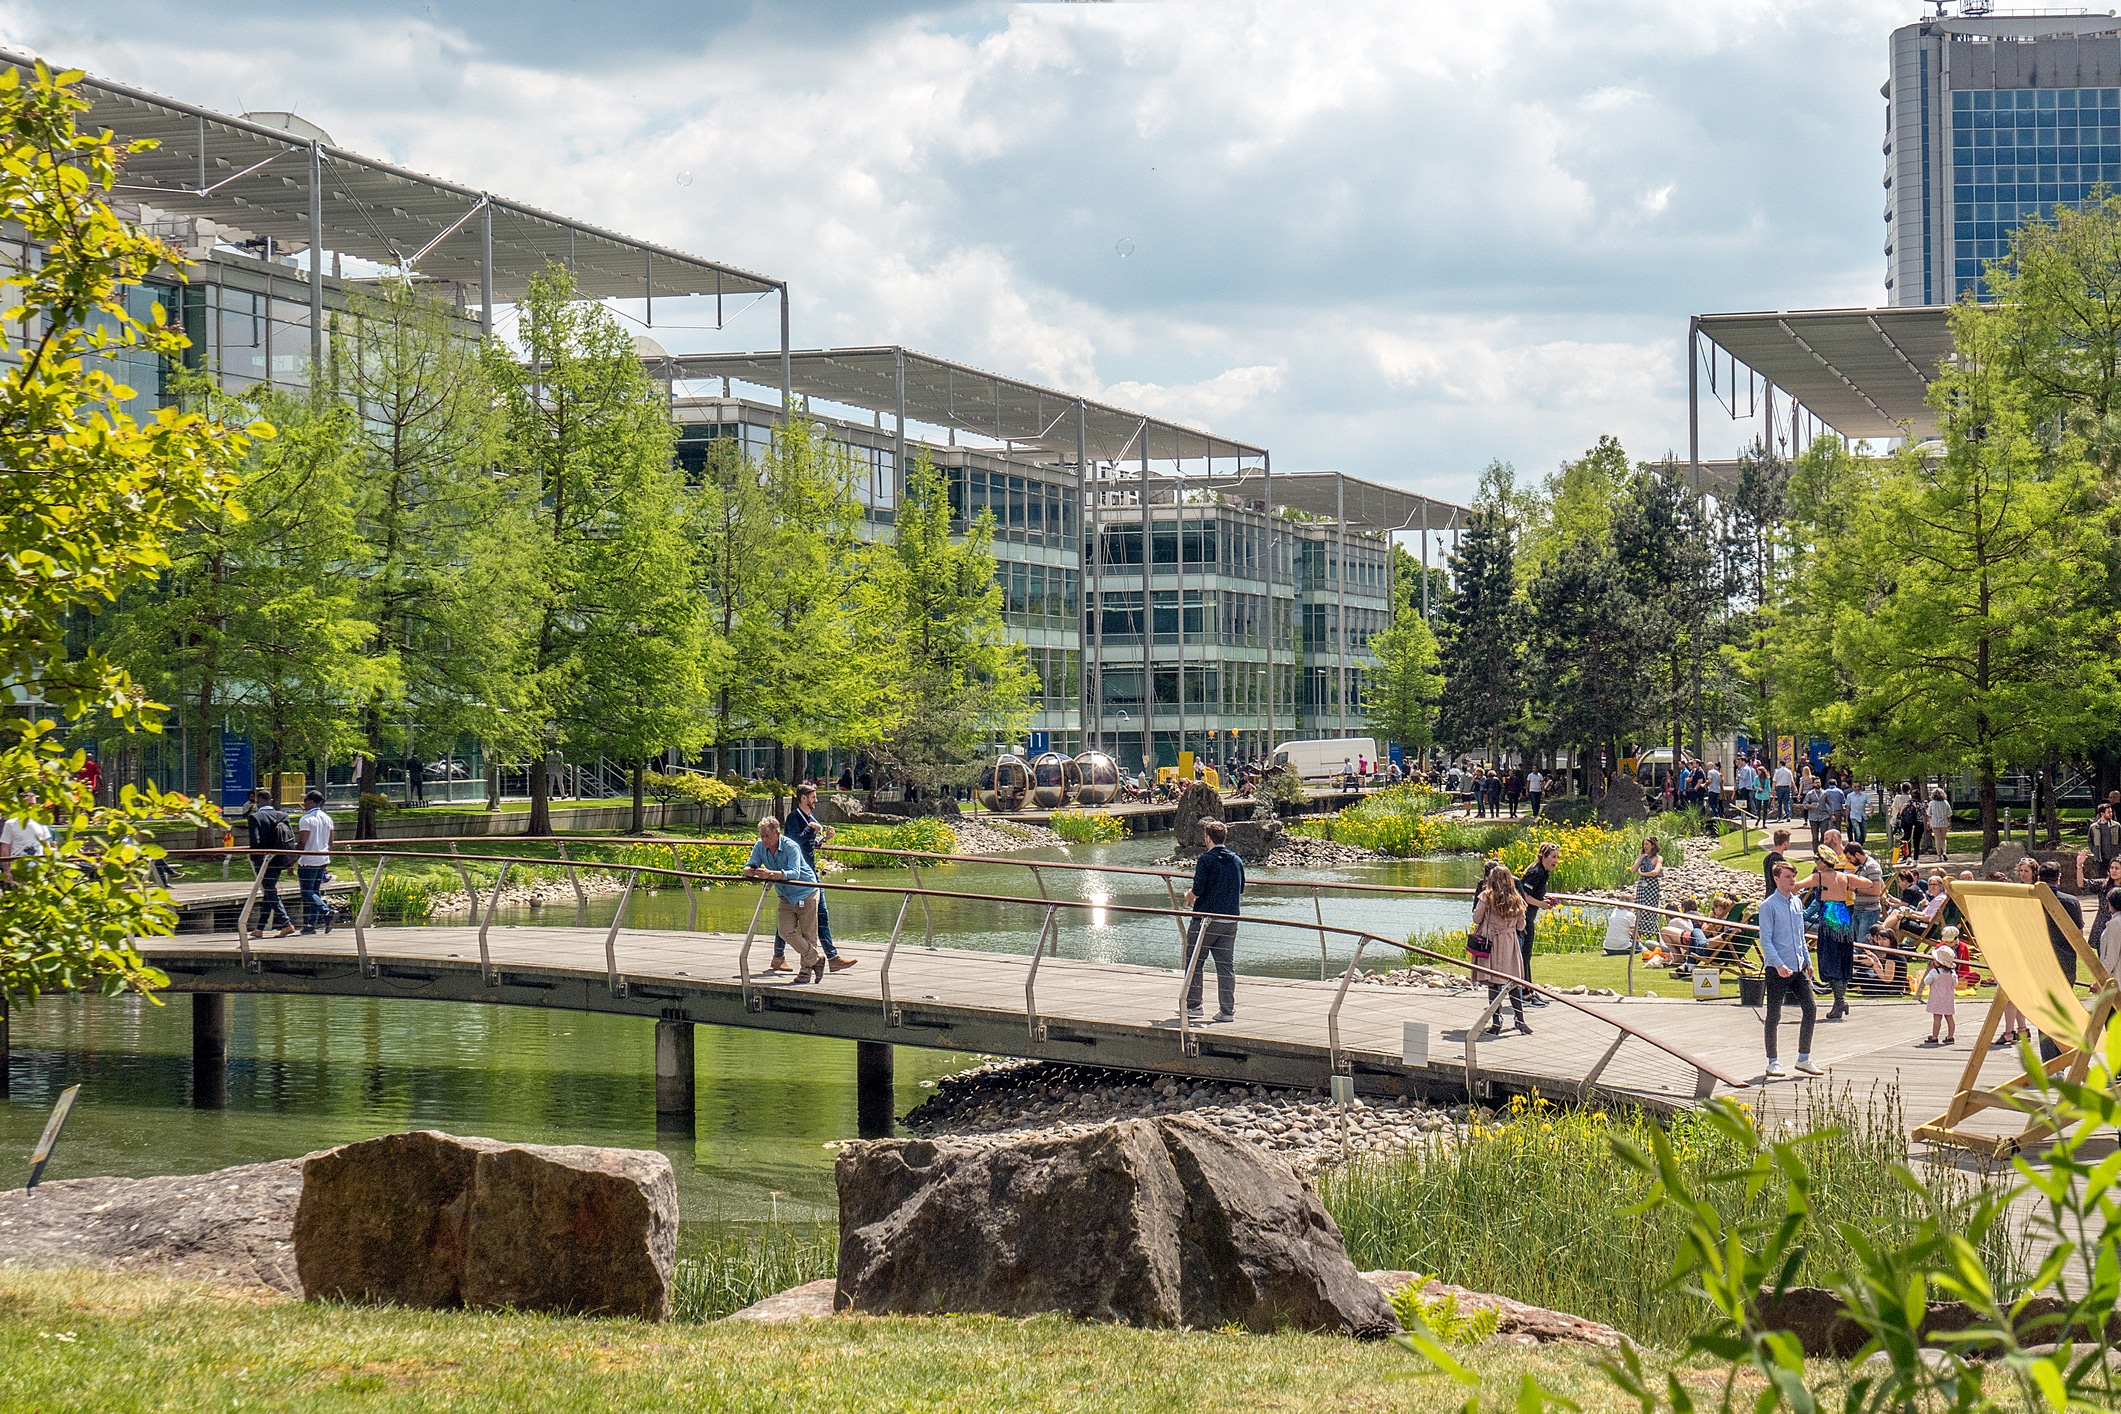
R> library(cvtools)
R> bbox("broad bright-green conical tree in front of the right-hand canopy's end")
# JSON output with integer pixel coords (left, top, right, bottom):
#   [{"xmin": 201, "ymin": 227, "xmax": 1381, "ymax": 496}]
[{"xmin": 1792, "ymin": 305, "xmax": 2121, "ymax": 850}]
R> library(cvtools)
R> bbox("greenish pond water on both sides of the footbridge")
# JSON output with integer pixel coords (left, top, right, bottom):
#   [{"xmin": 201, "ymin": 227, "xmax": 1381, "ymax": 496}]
[{"xmin": 0, "ymin": 835, "xmax": 1474, "ymax": 1221}]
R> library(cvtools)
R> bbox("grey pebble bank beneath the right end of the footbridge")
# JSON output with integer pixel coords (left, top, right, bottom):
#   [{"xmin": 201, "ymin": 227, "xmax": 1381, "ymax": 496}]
[{"xmin": 901, "ymin": 1060, "xmax": 1491, "ymax": 1177}]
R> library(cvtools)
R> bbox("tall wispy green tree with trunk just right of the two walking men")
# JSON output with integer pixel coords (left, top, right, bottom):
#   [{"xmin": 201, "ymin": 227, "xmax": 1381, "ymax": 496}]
[{"xmin": 331, "ymin": 280, "xmax": 523, "ymax": 839}]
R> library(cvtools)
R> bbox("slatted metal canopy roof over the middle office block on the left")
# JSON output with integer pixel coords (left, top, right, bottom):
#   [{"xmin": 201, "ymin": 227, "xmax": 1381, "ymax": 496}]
[{"xmin": 651, "ymin": 346, "xmax": 1266, "ymax": 462}]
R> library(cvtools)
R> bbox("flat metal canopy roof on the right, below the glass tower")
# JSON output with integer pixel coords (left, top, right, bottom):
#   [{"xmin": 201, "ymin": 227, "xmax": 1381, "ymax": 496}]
[{"xmin": 1697, "ymin": 305, "xmax": 1951, "ymax": 439}]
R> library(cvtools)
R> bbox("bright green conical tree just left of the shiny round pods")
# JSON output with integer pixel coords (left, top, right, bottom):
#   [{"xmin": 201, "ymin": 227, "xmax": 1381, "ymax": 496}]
[{"xmin": 874, "ymin": 452, "xmax": 1035, "ymax": 791}]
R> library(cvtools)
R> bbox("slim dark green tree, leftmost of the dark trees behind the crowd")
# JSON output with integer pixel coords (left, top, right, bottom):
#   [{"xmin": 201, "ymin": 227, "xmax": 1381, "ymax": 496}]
[{"xmin": 1436, "ymin": 498, "xmax": 1525, "ymax": 748}]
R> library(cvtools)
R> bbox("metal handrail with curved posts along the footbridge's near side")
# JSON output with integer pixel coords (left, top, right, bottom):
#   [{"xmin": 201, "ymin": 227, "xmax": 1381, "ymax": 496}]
[{"xmin": 165, "ymin": 842, "xmax": 1748, "ymax": 1090}]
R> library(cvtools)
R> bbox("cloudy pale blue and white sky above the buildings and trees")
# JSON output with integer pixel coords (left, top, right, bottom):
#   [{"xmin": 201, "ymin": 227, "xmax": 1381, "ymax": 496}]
[{"xmin": 0, "ymin": 0, "xmax": 1928, "ymax": 502}]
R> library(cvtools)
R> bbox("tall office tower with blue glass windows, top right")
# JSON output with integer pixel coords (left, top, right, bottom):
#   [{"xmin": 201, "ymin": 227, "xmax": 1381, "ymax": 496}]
[{"xmin": 1881, "ymin": 15, "xmax": 2121, "ymax": 305}]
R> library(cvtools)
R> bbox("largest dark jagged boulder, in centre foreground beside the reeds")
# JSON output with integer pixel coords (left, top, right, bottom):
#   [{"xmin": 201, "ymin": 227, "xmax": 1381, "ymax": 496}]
[{"xmin": 834, "ymin": 1117, "xmax": 1398, "ymax": 1338}]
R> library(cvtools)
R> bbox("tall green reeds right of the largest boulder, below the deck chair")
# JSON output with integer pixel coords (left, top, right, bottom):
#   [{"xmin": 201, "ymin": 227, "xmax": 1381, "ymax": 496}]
[{"xmin": 1319, "ymin": 1088, "xmax": 2030, "ymax": 1346}]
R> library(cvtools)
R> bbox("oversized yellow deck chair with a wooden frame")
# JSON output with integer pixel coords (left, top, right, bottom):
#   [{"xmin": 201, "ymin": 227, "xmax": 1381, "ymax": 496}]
[{"xmin": 1913, "ymin": 880, "xmax": 2117, "ymax": 1157}]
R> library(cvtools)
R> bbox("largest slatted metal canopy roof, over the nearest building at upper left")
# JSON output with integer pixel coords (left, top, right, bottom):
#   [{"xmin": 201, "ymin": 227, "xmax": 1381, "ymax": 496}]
[{"xmin": 12, "ymin": 49, "xmax": 781, "ymax": 303}]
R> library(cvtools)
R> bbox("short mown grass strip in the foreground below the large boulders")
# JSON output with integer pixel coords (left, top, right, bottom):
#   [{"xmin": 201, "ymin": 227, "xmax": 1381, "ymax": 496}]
[{"xmin": 0, "ymin": 1270, "xmax": 1631, "ymax": 1414}]
